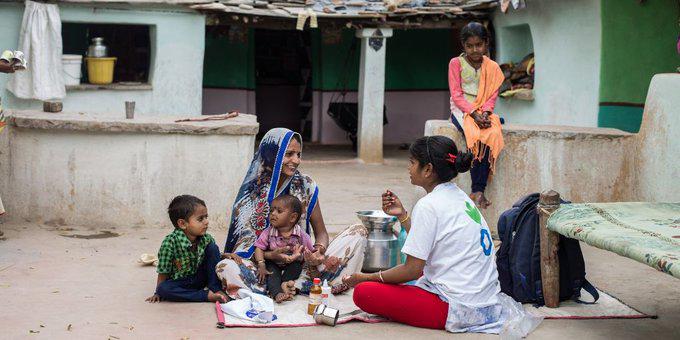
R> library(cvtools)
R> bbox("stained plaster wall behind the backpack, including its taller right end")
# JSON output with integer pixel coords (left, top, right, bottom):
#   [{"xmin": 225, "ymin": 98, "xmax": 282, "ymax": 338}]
[{"xmin": 421, "ymin": 74, "xmax": 680, "ymax": 228}]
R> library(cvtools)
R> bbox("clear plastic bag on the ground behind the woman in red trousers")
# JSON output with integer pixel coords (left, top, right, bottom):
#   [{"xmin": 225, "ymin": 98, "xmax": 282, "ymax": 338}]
[{"xmin": 498, "ymin": 293, "xmax": 543, "ymax": 340}]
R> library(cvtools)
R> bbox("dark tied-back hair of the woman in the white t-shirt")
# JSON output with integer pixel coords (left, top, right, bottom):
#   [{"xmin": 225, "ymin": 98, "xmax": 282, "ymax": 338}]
[{"xmin": 409, "ymin": 136, "xmax": 472, "ymax": 183}]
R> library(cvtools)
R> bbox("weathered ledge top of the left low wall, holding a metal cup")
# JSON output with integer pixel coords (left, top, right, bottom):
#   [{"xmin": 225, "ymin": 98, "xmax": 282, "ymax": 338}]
[{"xmin": 5, "ymin": 110, "xmax": 259, "ymax": 135}]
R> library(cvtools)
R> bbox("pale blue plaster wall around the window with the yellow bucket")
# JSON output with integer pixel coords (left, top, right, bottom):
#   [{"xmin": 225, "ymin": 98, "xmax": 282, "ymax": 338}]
[{"xmin": 0, "ymin": 3, "xmax": 205, "ymax": 116}]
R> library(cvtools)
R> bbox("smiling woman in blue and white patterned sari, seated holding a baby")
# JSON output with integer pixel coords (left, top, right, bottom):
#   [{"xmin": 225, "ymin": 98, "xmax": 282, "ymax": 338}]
[{"xmin": 216, "ymin": 128, "xmax": 367, "ymax": 298}]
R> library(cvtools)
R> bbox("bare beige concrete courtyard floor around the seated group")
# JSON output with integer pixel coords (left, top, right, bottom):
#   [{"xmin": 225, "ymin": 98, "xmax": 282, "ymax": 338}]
[{"xmin": 0, "ymin": 148, "xmax": 680, "ymax": 339}]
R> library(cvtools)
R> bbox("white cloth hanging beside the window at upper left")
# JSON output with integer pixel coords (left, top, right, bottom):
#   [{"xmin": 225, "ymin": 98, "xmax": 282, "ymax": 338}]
[{"xmin": 7, "ymin": 0, "xmax": 66, "ymax": 101}]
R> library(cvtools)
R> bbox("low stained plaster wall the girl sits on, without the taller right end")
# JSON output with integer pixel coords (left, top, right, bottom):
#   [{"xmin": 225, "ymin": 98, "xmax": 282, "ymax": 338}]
[{"xmin": 420, "ymin": 120, "xmax": 635, "ymax": 233}]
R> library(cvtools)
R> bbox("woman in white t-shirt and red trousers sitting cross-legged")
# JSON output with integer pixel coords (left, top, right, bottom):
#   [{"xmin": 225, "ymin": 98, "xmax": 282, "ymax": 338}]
[{"xmin": 344, "ymin": 136, "xmax": 540, "ymax": 335}]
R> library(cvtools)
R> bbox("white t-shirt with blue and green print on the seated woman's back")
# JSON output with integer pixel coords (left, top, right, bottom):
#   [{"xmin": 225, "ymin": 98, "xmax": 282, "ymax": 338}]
[{"xmin": 402, "ymin": 183, "xmax": 500, "ymax": 332}]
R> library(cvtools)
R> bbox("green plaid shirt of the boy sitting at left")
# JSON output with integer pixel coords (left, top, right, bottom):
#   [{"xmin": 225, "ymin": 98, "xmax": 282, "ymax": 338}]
[{"xmin": 156, "ymin": 229, "xmax": 215, "ymax": 280}]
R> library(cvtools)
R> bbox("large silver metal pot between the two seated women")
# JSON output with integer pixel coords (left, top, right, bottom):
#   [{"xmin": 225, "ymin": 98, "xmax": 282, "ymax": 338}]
[{"xmin": 357, "ymin": 210, "xmax": 399, "ymax": 272}]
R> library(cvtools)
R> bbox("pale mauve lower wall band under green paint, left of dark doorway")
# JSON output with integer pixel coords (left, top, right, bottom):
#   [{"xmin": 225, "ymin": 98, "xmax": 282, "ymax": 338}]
[{"xmin": 202, "ymin": 88, "xmax": 256, "ymax": 114}]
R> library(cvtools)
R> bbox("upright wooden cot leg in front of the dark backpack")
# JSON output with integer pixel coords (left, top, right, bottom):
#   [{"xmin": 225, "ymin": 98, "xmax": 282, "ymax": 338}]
[{"xmin": 538, "ymin": 190, "xmax": 560, "ymax": 308}]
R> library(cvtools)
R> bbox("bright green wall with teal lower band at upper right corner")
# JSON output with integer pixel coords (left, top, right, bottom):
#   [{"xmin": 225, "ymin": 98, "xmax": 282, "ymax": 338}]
[{"xmin": 598, "ymin": 0, "xmax": 680, "ymax": 132}]
